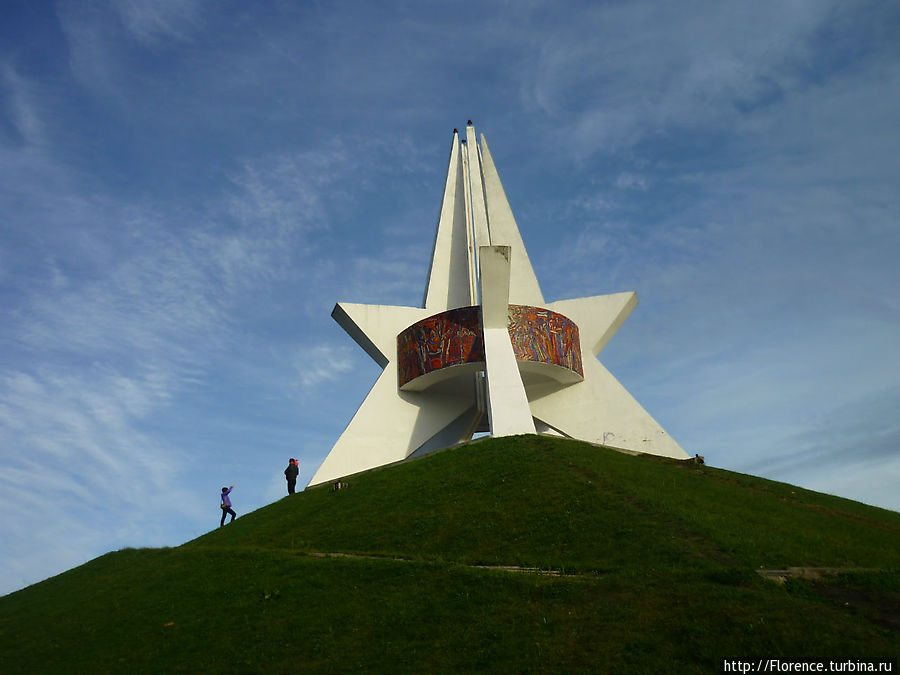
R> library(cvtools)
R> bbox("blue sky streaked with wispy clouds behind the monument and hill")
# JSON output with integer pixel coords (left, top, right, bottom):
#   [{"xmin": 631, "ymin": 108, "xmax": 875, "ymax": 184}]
[{"xmin": 0, "ymin": 0, "xmax": 900, "ymax": 593}]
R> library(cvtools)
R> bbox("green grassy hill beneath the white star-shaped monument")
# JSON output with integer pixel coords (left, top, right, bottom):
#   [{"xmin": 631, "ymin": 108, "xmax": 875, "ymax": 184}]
[{"xmin": 0, "ymin": 436, "xmax": 900, "ymax": 673}]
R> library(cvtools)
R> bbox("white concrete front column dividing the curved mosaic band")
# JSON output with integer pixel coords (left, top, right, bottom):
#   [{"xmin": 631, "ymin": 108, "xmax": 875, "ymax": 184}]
[{"xmin": 478, "ymin": 246, "xmax": 535, "ymax": 436}]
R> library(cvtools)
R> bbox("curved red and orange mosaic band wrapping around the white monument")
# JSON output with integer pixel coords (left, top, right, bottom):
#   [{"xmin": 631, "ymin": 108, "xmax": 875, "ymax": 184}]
[{"xmin": 397, "ymin": 305, "xmax": 584, "ymax": 387}]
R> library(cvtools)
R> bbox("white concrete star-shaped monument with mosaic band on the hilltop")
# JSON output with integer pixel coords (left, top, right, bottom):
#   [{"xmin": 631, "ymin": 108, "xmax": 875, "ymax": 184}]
[{"xmin": 309, "ymin": 122, "xmax": 688, "ymax": 492}]
